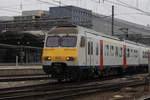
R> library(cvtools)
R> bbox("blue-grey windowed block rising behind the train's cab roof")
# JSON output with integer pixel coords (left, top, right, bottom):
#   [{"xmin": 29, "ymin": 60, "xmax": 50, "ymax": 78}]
[{"xmin": 49, "ymin": 6, "xmax": 92, "ymax": 28}]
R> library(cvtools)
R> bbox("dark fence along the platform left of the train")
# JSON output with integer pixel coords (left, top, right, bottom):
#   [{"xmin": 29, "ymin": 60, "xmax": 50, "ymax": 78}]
[{"xmin": 0, "ymin": 44, "xmax": 42, "ymax": 65}]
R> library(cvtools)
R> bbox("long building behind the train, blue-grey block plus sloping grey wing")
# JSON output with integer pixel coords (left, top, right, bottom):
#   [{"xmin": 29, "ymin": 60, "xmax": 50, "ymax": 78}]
[{"xmin": 49, "ymin": 6, "xmax": 150, "ymax": 44}]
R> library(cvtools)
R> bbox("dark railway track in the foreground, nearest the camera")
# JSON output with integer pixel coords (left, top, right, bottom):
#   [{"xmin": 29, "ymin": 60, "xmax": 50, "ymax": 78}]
[{"xmin": 0, "ymin": 74, "xmax": 148, "ymax": 100}]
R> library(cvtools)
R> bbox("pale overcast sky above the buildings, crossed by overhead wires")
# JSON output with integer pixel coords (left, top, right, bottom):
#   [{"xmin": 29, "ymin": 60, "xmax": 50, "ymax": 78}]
[{"xmin": 0, "ymin": 0, "xmax": 150, "ymax": 25}]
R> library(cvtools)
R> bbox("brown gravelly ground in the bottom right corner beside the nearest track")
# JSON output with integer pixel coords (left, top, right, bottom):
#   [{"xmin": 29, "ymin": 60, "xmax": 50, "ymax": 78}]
[{"xmin": 68, "ymin": 86, "xmax": 150, "ymax": 100}]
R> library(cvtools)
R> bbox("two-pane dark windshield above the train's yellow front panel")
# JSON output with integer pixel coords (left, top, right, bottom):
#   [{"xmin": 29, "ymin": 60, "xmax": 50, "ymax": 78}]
[{"xmin": 46, "ymin": 36, "xmax": 77, "ymax": 47}]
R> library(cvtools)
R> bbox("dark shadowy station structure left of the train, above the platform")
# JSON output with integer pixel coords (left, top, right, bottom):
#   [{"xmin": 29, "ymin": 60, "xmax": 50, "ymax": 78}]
[{"xmin": 0, "ymin": 31, "xmax": 43, "ymax": 65}]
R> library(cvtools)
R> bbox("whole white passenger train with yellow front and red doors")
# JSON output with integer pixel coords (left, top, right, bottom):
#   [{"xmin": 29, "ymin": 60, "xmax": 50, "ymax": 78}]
[{"xmin": 42, "ymin": 26, "xmax": 150, "ymax": 81}]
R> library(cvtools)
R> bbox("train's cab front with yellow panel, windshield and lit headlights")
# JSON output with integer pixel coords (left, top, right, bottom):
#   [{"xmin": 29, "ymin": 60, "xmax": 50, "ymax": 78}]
[{"xmin": 42, "ymin": 27, "xmax": 79, "ymax": 80}]
